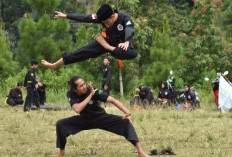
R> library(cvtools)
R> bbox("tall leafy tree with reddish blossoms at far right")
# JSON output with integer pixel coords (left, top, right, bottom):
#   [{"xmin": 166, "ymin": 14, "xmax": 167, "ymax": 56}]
[{"xmin": 179, "ymin": 0, "xmax": 231, "ymax": 83}]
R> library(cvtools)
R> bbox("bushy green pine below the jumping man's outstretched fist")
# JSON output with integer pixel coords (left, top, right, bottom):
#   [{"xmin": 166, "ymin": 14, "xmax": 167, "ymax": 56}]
[{"xmin": 16, "ymin": 14, "xmax": 72, "ymax": 66}]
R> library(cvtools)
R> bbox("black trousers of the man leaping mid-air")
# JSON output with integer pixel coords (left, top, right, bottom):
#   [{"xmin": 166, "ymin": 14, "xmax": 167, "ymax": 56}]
[{"xmin": 62, "ymin": 41, "xmax": 137, "ymax": 64}]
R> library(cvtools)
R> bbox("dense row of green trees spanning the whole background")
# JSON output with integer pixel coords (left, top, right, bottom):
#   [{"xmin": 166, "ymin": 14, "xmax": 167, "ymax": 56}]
[{"xmin": 0, "ymin": 0, "xmax": 232, "ymax": 96}]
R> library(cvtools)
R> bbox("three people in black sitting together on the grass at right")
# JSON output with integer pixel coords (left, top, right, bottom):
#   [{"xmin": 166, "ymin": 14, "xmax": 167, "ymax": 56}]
[{"xmin": 130, "ymin": 77, "xmax": 197, "ymax": 110}]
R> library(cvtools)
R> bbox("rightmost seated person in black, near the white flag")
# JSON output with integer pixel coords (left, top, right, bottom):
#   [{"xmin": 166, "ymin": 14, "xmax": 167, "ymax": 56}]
[{"xmin": 184, "ymin": 83, "xmax": 196, "ymax": 111}]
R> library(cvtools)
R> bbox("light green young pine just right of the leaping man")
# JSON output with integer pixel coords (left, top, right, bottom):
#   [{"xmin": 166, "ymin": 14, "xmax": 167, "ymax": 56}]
[{"xmin": 143, "ymin": 18, "xmax": 183, "ymax": 87}]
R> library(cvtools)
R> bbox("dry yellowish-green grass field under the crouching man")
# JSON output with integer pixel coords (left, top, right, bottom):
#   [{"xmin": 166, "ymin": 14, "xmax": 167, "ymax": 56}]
[{"xmin": 0, "ymin": 100, "xmax": 232, "ymax": 157}]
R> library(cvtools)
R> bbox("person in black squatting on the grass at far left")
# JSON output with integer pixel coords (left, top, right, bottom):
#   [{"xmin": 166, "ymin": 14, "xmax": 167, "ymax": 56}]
[{"xmin": 6, "ymin": 83, "xmax": 24, "ymax": 106}]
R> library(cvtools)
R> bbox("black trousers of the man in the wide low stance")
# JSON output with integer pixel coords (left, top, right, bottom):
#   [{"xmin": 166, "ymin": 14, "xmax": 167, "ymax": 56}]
[{"xmin": 56, "ymin": 114, "xmax": 139, "ymax": 149}]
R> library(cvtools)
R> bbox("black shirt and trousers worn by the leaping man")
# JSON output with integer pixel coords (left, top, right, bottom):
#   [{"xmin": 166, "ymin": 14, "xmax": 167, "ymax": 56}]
[{"xmin": 62, "ymin": 10, "xmax": 137, "ymax": 64}]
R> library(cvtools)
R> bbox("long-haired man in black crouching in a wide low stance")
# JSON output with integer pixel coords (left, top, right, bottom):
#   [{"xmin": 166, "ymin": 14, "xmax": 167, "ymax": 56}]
[{"xmin": 56, "ymin": 76, "xmax": 148, "ymax": 157}]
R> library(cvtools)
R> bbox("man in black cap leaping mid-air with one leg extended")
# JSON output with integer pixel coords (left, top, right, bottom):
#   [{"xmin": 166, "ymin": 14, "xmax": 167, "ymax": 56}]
[{"xmin": 41, "ymin": 4, "xmax": 137, "ymax": 69}]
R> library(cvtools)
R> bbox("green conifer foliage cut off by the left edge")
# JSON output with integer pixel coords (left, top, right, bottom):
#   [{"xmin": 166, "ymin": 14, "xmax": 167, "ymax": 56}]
[{"xmin": 0, "ymin": 29, "xmax": 18, "ymax": 79}]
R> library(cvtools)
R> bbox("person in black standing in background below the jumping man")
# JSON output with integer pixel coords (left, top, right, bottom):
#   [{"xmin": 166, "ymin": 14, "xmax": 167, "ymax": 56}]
[{"xmin": 102, "ymin": 57, "xmax": 112, "ymax": 95}]
